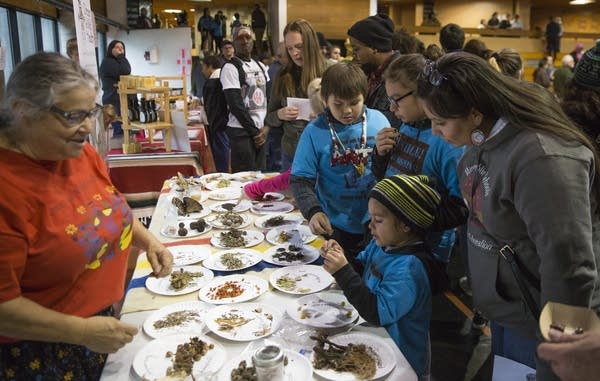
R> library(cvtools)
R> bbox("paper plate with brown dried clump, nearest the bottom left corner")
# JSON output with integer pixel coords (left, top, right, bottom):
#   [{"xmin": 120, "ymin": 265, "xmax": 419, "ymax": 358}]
[{"xmin": 132, "ymin": 333, "xmax": 227, "ymax": 380}]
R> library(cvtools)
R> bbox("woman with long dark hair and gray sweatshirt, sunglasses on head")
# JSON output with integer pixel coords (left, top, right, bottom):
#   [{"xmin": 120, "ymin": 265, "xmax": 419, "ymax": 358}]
[{"xmin": 416, "ymin": 52, "xmax": 600, "ymax": 381}]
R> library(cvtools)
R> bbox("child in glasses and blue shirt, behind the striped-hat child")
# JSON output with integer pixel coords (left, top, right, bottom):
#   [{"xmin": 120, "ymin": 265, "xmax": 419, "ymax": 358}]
[{"xmin": 372, "ymin": 54, "xmax": 463, "ymax": 263}]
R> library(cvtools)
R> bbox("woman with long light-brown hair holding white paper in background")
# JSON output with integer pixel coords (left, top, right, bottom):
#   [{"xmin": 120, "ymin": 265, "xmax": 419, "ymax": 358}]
[{"xmin": 265, "ymin": 19, "xmax": 327, "ymax": 171}]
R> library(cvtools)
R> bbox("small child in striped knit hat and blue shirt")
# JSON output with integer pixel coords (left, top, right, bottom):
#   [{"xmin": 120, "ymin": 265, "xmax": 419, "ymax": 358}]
[{"xmin": 321, "ymin": 175, "xmax": 441, "ymax": 378}]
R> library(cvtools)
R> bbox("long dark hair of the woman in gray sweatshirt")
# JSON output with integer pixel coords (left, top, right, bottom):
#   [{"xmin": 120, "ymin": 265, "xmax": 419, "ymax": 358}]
[{"xmin": 417, "ymin": 52, "xmax": 600, "ymax": 196}]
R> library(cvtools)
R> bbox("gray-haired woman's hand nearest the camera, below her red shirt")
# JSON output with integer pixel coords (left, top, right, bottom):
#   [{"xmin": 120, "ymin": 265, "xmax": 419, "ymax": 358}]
[{"xmin": 80, "ymin": 316, "xmax": 138, "ymax": 353}]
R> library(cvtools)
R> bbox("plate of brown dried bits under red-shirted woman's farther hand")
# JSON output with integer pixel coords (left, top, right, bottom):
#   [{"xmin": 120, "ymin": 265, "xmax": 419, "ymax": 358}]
[{"xmin": 146, "ymin": 266, "xmax": 214, "ymax": 296}]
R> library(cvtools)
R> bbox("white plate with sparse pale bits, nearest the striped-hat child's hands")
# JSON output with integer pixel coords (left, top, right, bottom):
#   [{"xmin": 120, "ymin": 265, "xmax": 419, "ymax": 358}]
[{"xmin": 269, "ymin": 265, "xmax": 333, "ymax": 295}]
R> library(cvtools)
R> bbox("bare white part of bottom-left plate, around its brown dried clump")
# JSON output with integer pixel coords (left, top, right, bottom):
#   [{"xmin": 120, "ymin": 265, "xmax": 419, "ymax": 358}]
[{"xmin": 132, "ymin": 334, "xmax": 227, "ymax": 381}]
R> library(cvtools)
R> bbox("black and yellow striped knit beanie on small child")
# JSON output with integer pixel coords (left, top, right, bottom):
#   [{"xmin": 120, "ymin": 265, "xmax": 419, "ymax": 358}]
[{"xmin": 369, "ymin": 175, "xmax": 441, "ymax": 230}]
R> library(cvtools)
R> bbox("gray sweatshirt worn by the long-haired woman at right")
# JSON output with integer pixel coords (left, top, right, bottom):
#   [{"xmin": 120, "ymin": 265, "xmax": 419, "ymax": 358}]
[{"xmin": 458, "ymin": 124, "xmax": 600, "ymax": 338}]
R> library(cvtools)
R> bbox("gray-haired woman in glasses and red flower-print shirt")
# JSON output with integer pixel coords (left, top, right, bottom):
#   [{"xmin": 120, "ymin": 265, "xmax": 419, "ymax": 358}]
[{"xmin": 0, "ymin": 53, "xmax": 173, "ymax": 380}]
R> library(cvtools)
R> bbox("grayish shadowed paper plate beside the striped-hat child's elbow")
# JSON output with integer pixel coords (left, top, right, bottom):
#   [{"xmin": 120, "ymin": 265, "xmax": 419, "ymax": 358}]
[{"xmin": 286, "ymin": 292, "xmax": 358, "ymax": 328}]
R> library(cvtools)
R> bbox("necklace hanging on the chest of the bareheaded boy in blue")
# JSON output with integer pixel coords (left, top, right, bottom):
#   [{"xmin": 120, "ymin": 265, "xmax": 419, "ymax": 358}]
[{"xmin": 327, "ymin": 111, "xmax": 373, "ymax": 176}]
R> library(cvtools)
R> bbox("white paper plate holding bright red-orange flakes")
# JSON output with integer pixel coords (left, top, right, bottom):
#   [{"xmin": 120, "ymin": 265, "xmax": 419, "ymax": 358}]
[{"xmin": 199, "ymin": 274, "xmax": 269, "ymax": 304}]
